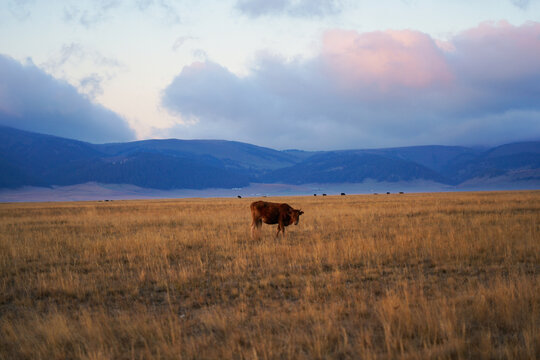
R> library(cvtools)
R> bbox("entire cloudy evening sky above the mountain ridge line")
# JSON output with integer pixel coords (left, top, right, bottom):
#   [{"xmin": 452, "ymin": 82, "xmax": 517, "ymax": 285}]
[{"xmin": 0, "ymin": 0, "xmax": 540, "ymax": 150}]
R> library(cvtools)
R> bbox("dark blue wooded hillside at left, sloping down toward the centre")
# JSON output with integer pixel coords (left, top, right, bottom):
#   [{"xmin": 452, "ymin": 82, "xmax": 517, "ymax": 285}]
[{"xmin": 0, "ymin": 127, "xmax": 249, "ymax": 189}]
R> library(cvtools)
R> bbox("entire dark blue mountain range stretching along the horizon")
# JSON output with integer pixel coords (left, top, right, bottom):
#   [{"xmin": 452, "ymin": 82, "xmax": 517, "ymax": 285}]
[{"xmin": 0, "ymin": 126, "xmax": 540, "ymax": 189}]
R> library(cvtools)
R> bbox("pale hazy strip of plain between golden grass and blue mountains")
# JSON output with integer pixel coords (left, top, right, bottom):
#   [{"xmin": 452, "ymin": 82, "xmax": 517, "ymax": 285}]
[{"xmin": 0, "ymin": 179, "xmax": 540, "ymax": 202}]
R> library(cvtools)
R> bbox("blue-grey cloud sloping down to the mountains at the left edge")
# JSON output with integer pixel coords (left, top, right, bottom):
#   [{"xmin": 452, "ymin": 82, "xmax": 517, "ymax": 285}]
[{"xmin": 0, "ymin": 55, "xmax": 135, "ymax": 143}]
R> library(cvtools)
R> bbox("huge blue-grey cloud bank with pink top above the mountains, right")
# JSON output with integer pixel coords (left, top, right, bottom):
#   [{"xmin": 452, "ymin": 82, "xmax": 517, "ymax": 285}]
[{"xmin": 162, "ymin": 23, "xmax": 540, "ymax": 149}]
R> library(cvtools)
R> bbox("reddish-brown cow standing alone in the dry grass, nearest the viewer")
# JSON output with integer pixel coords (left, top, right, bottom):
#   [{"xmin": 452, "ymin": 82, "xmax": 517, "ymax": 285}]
[{"xmin": 250, "ymin": 201, "xmax": 304, "ymax": 238}]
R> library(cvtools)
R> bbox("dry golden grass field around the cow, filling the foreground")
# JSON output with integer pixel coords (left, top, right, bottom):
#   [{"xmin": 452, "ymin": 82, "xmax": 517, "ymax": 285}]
[{"xmin": 0, "ymin": 191, "xmax": 540, "ymax": 359}]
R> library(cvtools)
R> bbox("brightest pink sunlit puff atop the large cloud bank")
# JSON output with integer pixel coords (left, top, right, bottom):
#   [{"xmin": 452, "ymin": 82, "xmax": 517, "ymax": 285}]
[{"xmin": 321, "ymin": 30, "xmax": 453, "ymax": 93}]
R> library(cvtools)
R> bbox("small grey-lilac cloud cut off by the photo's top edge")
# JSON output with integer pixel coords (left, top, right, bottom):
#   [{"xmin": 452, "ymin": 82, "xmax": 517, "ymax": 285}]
[{"xmin": 236, "ymin": 0, "xmax": 342, "ymax": 17}]
